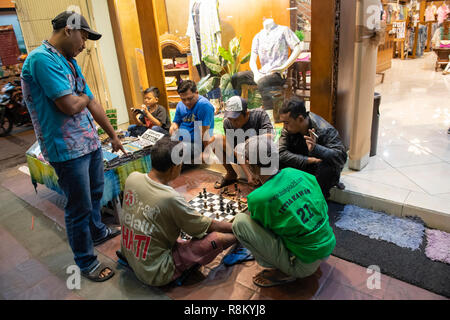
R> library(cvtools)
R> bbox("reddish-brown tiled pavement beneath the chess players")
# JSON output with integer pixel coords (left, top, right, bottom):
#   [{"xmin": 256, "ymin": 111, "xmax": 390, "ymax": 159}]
[{"xmin": 0, "ymin": 168, "xmax": 445, "ymax": 300}]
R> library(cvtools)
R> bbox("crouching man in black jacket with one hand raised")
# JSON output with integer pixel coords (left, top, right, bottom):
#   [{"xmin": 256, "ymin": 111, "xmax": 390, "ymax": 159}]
[{"xmin": 279, "ymin": 98, "xmax": 347, "ymax": 198}]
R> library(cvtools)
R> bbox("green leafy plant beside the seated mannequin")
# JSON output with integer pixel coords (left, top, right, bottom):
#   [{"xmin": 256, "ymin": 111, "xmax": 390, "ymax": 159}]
[{"xmin": 198, "ymin": 37, "xmax": 250, "ymax": 101}]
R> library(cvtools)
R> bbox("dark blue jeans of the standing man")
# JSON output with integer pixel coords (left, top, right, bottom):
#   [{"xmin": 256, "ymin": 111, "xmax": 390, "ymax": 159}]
[{"xmin": 51, "ymin": 148, "xmax": 106, "ymax": 271}]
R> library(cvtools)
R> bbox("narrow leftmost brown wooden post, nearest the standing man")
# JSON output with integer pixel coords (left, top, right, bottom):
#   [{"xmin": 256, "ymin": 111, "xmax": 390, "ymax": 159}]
[{"xmin": 108, "ymin": 0, "xmax": 136, "ymax": 124}]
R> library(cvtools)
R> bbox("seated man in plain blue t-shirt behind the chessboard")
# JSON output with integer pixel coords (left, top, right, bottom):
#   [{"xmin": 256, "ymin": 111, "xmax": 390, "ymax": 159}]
[{"xmin": 169, "ymin": 80, "xmax": 214, "ymax": 164}]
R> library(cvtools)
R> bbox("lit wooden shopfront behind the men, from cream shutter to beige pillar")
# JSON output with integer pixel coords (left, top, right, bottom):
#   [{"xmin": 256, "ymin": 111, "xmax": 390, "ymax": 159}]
[{"xmin": 16, "ymin": 0, "xmax": 381, "ymax": 195}]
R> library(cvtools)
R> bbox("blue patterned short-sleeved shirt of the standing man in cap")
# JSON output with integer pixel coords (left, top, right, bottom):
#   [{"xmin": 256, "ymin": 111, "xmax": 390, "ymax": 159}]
[{"xmin": 21, "ymin": 41, "xmax": 101, "ymax": 162}]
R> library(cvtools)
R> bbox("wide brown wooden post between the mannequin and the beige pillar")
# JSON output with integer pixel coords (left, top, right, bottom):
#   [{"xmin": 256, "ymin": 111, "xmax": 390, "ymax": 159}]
[{"xmin": 311, "ymin": 0, "xmax": 336, "ymax": 124}]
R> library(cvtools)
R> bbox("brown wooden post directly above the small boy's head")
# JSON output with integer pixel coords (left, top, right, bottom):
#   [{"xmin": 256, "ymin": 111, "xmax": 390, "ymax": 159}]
[{"xmin": 136, "ymin": 0, "xmax": 169, "ymax": 112}]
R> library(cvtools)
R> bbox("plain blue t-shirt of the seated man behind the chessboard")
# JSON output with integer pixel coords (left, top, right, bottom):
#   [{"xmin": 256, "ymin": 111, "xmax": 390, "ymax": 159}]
[{"xmin": 173, "ymin": 96, "xmax": 214, "ymax": 143}]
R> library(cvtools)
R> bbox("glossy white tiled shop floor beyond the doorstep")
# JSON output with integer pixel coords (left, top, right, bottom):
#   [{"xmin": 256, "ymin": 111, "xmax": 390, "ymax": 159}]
[{"xmin": 333, "ymin": 52, "xmax": 450, "ymax": 232}]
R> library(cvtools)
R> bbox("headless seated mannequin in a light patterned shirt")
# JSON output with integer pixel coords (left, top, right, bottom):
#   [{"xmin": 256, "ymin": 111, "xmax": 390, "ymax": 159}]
[{"xmin": 232, "ymin": 18, "xmax": 302, "ymax": 110}]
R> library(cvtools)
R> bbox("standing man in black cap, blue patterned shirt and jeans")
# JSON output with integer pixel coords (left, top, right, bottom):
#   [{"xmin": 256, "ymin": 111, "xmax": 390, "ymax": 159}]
[{"xmin": 21, "ymin": 11, "xmax": 126, "ymax": 282}]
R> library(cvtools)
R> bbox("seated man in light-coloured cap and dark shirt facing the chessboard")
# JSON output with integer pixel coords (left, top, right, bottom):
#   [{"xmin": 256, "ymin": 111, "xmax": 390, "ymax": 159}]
[{"xmin": 213, "ymin": 96, "xmax": 274, "ymax": 189}]
